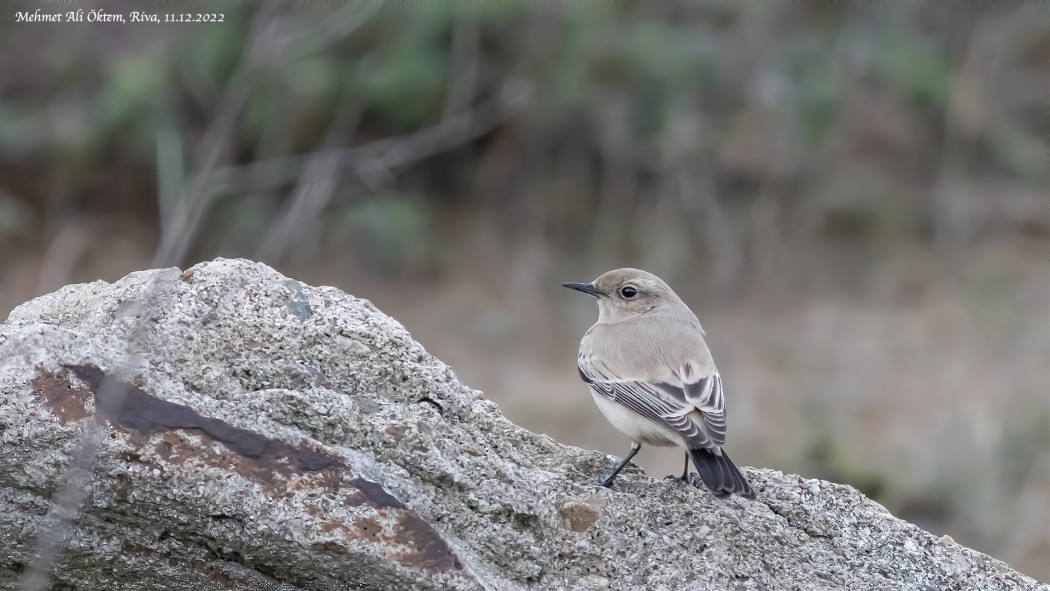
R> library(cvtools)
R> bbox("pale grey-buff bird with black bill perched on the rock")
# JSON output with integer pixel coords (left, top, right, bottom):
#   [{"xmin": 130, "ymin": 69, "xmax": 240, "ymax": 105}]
[{"xmin": 562, "ymin": 269, "xmax": 755, "ymax": 499}]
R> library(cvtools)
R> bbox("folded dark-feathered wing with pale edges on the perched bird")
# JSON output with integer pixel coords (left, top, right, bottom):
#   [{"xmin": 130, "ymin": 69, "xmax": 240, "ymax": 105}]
[{"xmin": 579, "ymin": 353, "xmax": 726, "ymax": 447}]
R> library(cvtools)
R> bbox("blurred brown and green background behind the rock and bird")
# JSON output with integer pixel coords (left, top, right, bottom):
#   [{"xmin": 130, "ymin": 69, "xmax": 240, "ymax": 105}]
[{"xmin": 0, "ymin": 0, "xmax": 1050, "ymax": 581}]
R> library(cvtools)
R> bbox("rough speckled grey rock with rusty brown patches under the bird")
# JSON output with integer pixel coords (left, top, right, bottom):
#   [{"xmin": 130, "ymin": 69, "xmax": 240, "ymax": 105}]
[{"xmin": 0, "ymin": 259, "xmax": 1050, "ymax": 591}]
